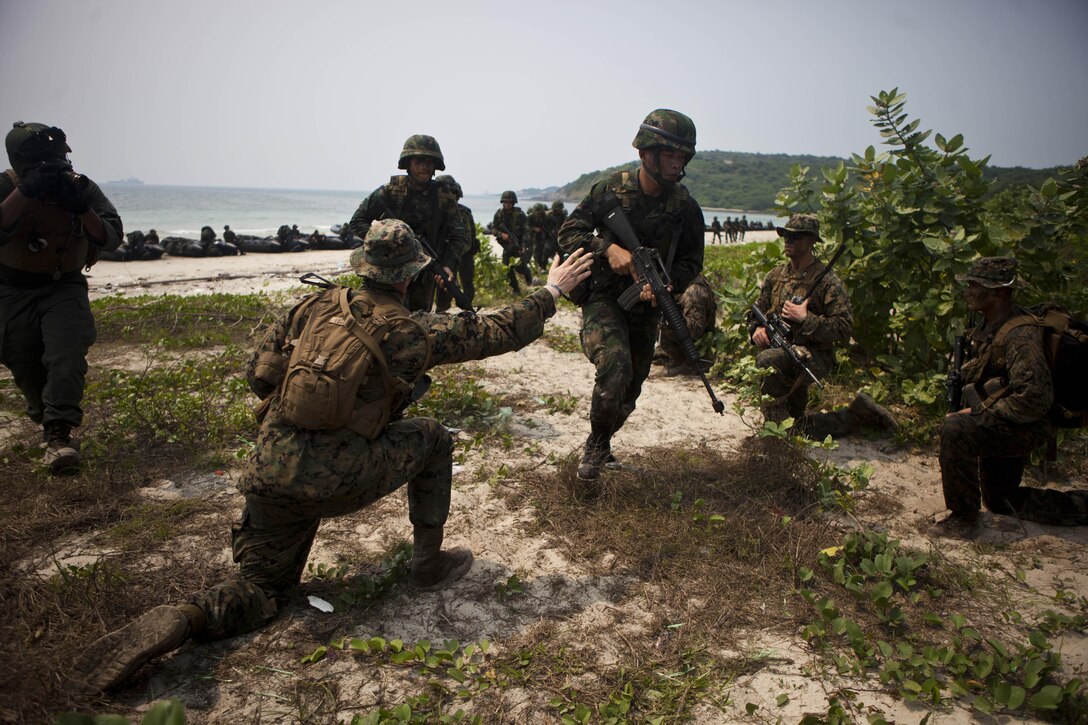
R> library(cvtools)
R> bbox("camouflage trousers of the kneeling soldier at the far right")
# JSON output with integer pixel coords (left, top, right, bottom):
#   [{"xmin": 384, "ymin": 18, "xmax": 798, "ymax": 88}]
[{"xmin": 940, "ymin": 413, "xmax": 1088, "ymax": 526}]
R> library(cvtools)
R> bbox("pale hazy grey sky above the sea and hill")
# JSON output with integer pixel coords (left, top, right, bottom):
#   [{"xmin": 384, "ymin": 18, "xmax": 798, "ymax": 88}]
[{"xmin": 0, "ymin": 0, "xmax": 1088, "ymax": 194}]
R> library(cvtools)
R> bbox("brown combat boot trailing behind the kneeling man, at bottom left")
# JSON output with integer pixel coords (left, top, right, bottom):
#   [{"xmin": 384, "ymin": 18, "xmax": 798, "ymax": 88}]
[{"xmin": 74, "ymin": 604, "xmax": 205, "ymax": 692}]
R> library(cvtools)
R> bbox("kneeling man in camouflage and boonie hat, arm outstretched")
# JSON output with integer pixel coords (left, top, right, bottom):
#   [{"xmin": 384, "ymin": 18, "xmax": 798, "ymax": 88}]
[{"xmin": 73, "ymin": 220, "xmax": 590, "ymax": 691}]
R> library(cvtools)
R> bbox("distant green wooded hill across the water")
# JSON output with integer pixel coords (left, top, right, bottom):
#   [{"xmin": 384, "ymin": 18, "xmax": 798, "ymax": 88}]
[{"xmin": 530, "ymin": 151, "xmax": 1059, "ymax": 211}]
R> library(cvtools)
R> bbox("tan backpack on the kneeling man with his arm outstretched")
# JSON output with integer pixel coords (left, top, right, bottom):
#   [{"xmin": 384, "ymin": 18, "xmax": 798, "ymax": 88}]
[{"xmin": 257, "ymin": 285, "xmax": 426, "ymax": 439}]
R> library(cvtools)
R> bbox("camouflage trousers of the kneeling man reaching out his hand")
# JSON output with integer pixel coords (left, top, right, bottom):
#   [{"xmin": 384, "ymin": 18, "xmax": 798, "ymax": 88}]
[{"xmin": 189, "ymin": 411, "xmax": 453, "ymax": 639}]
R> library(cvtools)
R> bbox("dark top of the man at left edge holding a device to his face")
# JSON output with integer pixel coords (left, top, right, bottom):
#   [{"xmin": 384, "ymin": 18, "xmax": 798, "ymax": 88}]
[{"xmin": 0, "ymin": 170, "xmax": 124, "ymax": 280}]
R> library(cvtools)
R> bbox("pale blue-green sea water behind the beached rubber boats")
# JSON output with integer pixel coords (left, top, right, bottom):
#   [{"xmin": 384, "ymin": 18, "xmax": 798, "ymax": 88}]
[{"xmin": 101, "ymin": 183, "xmax": 780, "ymax": 238}]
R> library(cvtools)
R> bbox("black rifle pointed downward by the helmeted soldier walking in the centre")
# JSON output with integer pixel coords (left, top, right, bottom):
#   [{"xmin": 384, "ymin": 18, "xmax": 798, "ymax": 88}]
[{"xmin": 599, "ymin": 196, "xmax": 726, "ymax": 416}]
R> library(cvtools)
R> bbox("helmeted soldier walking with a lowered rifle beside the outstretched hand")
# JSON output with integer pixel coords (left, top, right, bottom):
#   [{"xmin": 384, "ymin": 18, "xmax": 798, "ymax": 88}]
[{"xmin": 559, "ymin": 109, "xmax": 704, "ymax": 478}]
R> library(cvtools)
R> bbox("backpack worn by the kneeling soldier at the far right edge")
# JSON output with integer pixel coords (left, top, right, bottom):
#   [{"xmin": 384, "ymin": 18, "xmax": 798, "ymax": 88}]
[{"xmin": 993, "ymin": 303, "xmax": 1088, "ymax": 428}]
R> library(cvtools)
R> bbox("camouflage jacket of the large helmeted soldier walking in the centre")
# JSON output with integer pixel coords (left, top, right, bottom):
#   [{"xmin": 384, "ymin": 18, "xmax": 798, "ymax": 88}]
[{"xmin": 559, "ymin": 170, "xmax": 704, "ymax": 305}]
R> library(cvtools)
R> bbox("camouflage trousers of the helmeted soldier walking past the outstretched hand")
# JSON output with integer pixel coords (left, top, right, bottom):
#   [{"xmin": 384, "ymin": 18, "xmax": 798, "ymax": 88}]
[{"xmin": 581, "ymin": 292, "xmax": 657, "ymax": 441}]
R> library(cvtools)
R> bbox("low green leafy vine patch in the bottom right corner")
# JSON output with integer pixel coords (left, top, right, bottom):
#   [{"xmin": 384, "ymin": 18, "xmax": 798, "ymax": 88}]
[{"xmin": 798, "ymin": 531, "xmax": 1088, "ymax": 716}]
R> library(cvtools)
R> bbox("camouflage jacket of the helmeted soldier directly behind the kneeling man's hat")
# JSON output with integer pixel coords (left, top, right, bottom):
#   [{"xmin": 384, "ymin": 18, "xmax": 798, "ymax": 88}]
[{"xmin": 349, "ymin": 174, "xmax": 469, "ymax": 269}]
